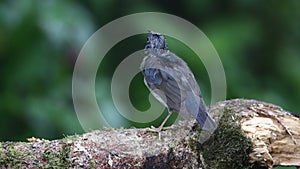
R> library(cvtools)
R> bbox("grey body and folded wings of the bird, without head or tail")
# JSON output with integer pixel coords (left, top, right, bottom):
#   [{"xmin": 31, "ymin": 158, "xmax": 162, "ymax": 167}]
[{"xmin": 141, "ymin": 53, "xmax": 200, "ymax": 119}]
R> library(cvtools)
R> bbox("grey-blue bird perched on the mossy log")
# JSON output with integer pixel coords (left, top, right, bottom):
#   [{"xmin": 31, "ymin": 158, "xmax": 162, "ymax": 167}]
[{"xmin": 140, "ymin": 31, "xmax": 217, "ymax": 132}]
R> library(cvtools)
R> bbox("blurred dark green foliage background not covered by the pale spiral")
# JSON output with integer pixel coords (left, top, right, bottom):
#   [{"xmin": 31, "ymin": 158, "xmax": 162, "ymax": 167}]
[{"xmin": 0, "ymin": 0, "xmax": 300, "ymax": 154}]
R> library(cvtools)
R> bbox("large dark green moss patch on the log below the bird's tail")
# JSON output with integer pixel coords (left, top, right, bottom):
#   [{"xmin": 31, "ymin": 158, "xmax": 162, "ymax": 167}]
[{"xmin": 190, "ymin": 110, "xmax": 252, "ymax": 169}]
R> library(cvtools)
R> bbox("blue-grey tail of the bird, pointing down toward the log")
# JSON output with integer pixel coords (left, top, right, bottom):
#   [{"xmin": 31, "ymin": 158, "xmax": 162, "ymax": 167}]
[{"xmin": 196, "ymin": 106, "xmax": 217, "ymax": 131}]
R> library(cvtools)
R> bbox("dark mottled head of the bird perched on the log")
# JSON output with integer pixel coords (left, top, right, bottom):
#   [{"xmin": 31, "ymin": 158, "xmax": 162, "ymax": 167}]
[{"xmin": 145, "ymin": 31, "xmax": 168, "ymax": 50}]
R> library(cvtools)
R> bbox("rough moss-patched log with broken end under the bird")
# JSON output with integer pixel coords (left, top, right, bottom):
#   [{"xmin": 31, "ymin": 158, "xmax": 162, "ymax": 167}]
[{"xmin": 0, "ymin": 99, "xmax": 300, "ymax": 168}]
